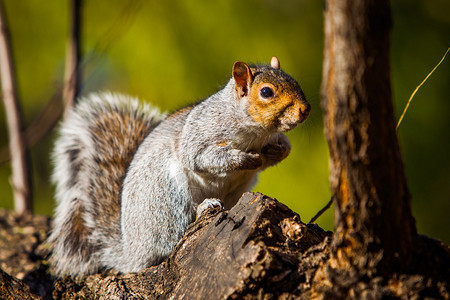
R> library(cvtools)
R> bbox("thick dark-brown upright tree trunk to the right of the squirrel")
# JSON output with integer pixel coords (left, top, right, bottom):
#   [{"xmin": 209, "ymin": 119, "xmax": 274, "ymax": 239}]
[{"xmin": 320, "ymin": 0, "xmax": 417, "ymax": 290}]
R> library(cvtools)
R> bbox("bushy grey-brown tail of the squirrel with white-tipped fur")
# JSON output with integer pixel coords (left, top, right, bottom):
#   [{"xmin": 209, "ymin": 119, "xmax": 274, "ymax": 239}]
[{"xmin": 49, "ymin": 93, "xmax": 164, "ymax": 276}]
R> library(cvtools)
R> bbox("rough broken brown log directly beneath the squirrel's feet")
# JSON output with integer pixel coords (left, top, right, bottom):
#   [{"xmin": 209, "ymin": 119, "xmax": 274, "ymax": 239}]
[{"xmin": 51, "ymin": 193, "xmax": 329, "ymax": 299}]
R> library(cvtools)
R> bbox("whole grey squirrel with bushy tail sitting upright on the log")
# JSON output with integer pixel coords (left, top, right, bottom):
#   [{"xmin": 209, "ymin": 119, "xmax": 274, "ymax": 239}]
[{"xmin": 49, "ymin": 57, "xmax": 311, "ymax": 278}]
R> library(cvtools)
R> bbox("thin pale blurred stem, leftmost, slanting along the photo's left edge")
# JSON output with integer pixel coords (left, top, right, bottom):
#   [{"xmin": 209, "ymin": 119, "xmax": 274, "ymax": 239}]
[{"xmin": 0, "ymin": 0, "xmax": 32, "ymax": 214}]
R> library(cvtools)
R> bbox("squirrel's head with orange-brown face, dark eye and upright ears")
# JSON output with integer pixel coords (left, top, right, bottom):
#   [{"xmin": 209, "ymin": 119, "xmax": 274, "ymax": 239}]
[{"xmin": 233, "ymin": 57, "xmax": 311, "ymax": 131}]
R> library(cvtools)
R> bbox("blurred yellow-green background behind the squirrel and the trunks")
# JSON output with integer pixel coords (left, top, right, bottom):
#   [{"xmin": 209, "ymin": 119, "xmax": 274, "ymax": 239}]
[{"xmin": 0, "ymin": 0, "xmax": 450, "ymax": 243}]
